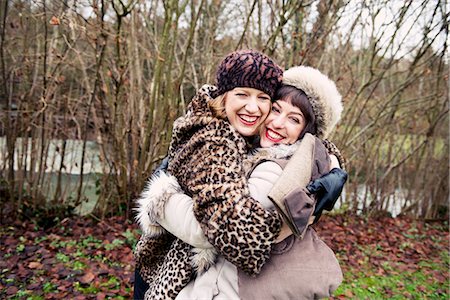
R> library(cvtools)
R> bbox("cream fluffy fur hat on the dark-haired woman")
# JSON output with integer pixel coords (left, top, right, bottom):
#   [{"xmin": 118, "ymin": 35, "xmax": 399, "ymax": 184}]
[{"xmin": 283, "ymin": 66, "xmax": 343, "ymax": 138}]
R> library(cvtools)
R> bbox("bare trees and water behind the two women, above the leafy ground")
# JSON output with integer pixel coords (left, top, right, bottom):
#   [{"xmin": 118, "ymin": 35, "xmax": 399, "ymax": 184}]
[{"xmin": 0, "ymin": 0, "xmax": 449, "ymax": 220}]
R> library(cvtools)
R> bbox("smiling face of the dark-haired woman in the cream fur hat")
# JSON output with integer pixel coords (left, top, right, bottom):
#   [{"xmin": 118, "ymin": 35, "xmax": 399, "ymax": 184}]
[{"xmin": 260, "ymin": 100, "xmax": 306, "ymax": 148}]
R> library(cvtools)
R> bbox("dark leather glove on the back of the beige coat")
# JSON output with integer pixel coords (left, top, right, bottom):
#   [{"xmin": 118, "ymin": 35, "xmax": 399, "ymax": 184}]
[{"xmin": 306, "ymin": 168, "xmax": 348, "ymax": 223}]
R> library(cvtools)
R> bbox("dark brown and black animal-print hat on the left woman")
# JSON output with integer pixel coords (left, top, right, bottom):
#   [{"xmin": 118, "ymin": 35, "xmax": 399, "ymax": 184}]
[{"xmin": 213, "ymin": 50, "xmax": 283, "ymax": 99}]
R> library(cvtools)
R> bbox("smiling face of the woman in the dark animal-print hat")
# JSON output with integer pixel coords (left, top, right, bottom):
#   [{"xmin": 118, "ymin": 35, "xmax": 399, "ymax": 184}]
[{"xmin": 224, "ymin": 87, "xmax": 271, "ymax": 137}]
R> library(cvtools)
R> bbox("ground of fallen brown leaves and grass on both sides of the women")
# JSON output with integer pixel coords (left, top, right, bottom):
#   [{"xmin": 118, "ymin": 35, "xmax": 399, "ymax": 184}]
[{"xmin": 0, "ymin": 215, "xmax": 450, "ymax": 299}]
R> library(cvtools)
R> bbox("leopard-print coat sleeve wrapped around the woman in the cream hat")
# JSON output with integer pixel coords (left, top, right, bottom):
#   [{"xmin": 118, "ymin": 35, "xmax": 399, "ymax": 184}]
[{"xmin": 191, "ymin": 134, "xmax": 281, "ymax": 275}]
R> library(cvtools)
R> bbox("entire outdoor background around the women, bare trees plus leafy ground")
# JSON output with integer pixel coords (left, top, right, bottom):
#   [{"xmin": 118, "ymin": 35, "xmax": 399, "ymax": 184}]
[{"xmin": 0, "ymin": 0, "xmax": 450, "ymax": 300}]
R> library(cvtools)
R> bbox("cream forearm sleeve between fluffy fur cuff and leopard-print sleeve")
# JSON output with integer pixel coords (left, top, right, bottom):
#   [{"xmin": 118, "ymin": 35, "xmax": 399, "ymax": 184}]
[{"xmin": 157, "ymin": 194, "xmax": 213, "ymax": 248}]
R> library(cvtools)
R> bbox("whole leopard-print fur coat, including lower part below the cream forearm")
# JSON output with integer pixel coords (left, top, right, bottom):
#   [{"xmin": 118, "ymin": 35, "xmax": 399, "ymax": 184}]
[{"xmin": 135, "ymin": 85, "xmax": 281, "ymax": 299}]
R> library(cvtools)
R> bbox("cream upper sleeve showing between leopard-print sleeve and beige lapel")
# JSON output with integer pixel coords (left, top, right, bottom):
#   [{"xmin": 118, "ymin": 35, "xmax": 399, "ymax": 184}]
[{"xmin": 248, "ymin": 161, "xmax": 283, "ymax": 208}]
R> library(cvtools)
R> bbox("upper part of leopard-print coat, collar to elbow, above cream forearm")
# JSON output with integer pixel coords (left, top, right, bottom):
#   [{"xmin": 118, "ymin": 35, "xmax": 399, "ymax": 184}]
[{"xmin": 168, "ymin": 86, "xmax": 281, "ymax": 275}]
